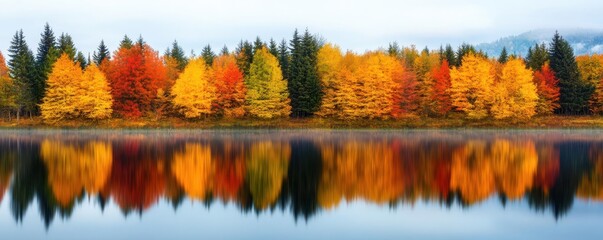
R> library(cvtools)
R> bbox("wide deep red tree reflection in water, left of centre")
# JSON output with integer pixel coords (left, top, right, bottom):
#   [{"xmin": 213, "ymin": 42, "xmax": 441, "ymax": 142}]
[{"xmin": 107, "ymin": 141, "xmax": 165, "ymax": 210}]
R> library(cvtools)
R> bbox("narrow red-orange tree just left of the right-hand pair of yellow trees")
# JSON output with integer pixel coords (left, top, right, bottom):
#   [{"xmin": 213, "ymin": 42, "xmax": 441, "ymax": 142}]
[{"xmin": 431, "ymin": 59, "xmax": 452, "ymax": 115}]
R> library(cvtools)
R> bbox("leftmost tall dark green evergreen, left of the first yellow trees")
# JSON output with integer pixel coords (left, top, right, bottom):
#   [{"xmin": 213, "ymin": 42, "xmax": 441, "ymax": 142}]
[{"xmin": 8, "ymin": 30, "xmax": 37, "ymax": 118}]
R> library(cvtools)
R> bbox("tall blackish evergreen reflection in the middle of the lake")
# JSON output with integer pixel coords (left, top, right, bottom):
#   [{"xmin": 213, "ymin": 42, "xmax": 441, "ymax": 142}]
[{"xmin": 281, "ymin": 140, "xmax": 322, "ymax": 220}]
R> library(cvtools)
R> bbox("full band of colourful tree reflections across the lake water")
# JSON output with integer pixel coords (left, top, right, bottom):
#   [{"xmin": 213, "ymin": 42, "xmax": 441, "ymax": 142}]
[{"xmin": 0, "ymin": 131, "xmax": 603, "ymax": 226}]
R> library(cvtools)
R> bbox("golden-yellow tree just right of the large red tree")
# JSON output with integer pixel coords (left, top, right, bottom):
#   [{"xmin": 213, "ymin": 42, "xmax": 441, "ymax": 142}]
[{"xmin": 171, "ymin": 58, "xmax": 216, "ymax": 118}]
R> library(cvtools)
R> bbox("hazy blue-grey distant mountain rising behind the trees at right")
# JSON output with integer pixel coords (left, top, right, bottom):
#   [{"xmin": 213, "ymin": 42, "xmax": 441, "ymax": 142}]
[{"xmin": 476, "ymin": 29, "xmax": 603, "ymax": 57}]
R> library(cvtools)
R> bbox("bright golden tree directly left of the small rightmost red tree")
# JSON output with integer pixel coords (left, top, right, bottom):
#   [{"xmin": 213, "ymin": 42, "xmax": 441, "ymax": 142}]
[{"xmin": 491, "ymin": 58, "xmax": 538, "ymax": 119}]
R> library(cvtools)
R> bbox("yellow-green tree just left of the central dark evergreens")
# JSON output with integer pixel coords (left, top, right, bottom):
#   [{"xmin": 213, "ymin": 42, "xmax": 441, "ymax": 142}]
[{"xmin": 245, "ymin": 48, "xmax": 291, "ymax": 118}]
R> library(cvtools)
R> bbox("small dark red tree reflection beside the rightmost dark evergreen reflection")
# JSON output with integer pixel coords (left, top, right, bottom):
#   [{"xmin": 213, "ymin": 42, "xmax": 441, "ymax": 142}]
[{"xmin": 534, "ymin": 144, "xmax": 559, "ymax": 192}]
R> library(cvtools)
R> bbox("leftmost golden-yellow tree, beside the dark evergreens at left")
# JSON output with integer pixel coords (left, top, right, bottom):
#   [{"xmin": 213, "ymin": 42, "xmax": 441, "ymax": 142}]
[{"xmin": 40, "ymin": 53, "xmax": 82, "ymax": 122}]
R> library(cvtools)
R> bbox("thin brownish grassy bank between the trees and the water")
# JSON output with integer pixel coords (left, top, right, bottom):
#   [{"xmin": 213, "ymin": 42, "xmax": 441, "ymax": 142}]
[{"xmin": 0, "ymin": 116, "xmax": 603, "ymax": 129}]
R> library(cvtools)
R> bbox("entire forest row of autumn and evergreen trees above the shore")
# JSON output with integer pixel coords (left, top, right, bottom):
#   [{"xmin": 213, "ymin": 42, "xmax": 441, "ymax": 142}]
[{"xmin": 0, "ymin": 24, "xmax": 603, "ymax": 125}]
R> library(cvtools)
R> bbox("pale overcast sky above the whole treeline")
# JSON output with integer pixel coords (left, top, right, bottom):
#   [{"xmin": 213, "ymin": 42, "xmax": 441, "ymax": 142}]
[{"xmin": 0, "ymin": 0, "xmax": 603, "ymax": 56}]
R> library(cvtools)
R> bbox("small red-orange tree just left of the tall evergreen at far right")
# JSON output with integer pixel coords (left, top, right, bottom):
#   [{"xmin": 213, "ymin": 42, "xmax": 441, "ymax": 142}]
[{"xmin": 534, "ymin": 63, "xmax": 559, "ymax": 115}]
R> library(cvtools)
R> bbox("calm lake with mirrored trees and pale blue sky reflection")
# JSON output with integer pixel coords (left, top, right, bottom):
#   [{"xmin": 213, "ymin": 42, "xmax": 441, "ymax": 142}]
[{"xmin": 0, "ymin": 130, "xmax": 603, "ymax": 239}]
